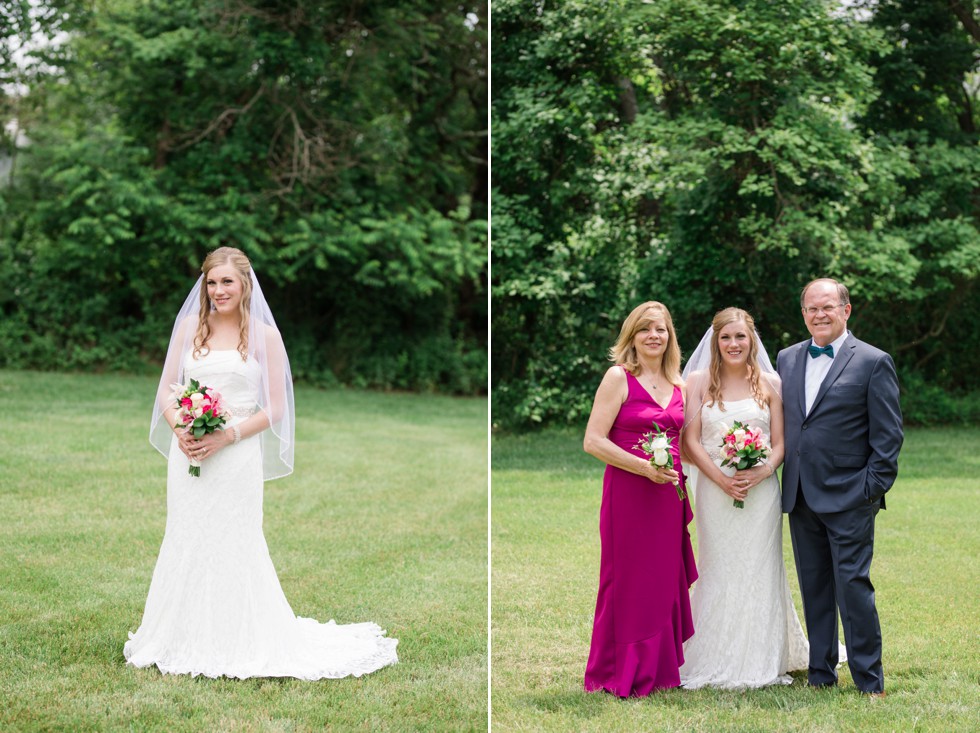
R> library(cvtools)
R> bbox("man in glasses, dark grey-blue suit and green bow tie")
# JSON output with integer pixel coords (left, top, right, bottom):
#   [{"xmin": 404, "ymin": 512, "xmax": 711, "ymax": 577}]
[{"xmin": 776, "ymin": 278, "xmax": 903, "ymax": 697}]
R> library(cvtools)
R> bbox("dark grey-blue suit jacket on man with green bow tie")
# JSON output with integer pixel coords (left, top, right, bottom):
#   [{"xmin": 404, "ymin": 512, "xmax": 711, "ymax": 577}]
[{"xmin": 776, "ymin": 333, "xmax": 903, "ymax": 513}]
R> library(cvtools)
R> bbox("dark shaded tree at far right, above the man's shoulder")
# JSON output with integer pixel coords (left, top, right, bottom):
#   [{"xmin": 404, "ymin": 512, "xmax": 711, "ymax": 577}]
[{"xmin": 846, "ymin": 0, "xmax": 980, "ymax": 392}]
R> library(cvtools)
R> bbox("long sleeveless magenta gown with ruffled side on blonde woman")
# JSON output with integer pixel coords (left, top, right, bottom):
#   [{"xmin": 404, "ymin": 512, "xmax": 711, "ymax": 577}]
[{"xmin": 585, "ymin": 372, "xmax": 698, "ymax": 697}]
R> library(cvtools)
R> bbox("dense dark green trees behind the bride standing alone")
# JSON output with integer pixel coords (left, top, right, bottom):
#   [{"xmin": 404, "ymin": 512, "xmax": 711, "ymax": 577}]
[{"xmin": 0, "ymin": 0, "xmax": 488, "ymax": 392}]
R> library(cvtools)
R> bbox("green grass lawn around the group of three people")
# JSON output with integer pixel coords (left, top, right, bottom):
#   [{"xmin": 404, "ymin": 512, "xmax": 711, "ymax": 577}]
[{"xmin": 491, "ymin": 428, "xmax": 980, "ymax": 733}]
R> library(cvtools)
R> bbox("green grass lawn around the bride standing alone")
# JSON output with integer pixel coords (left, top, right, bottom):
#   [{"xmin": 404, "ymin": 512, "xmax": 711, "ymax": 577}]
[{"xmin": 0, "ymin": 371, "xmax": 487, "ymax": 731}]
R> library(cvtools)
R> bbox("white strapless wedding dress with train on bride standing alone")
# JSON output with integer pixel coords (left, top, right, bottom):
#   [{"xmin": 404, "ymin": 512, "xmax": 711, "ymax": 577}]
[{"xmin": 123, "ymin": 350, "xmax": 398, "ymax": 680}]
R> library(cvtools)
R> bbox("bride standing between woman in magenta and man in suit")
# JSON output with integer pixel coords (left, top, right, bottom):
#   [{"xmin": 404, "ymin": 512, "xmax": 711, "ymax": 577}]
[{"xmin": 680, "ymin": 308, "xmax": 808, "ymax": 689}]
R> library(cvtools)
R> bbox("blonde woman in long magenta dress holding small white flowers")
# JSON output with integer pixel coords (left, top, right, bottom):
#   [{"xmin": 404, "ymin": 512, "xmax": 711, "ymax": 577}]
[{"xmin": 584, "ymin": 301, "xmax": 697, "ymax": 697}]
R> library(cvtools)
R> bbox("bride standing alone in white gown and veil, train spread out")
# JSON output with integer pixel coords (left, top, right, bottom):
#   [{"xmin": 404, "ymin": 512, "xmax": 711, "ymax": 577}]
[{"xmin": 123, "ymin": 247, "xmax": 398, "ymax": 680}]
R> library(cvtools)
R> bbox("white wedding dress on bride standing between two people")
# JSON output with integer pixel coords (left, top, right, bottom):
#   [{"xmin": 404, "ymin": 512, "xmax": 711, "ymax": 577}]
[{"xmin": 680, "ymin": 398, "xmax": 809, "ymax": 689}]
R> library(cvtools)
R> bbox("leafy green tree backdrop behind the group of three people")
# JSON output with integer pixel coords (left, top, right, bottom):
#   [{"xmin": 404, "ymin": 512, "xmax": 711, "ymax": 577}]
[{"xmin": 492, "ymin": 0, "xmax": 980, "ymax": 425}]
